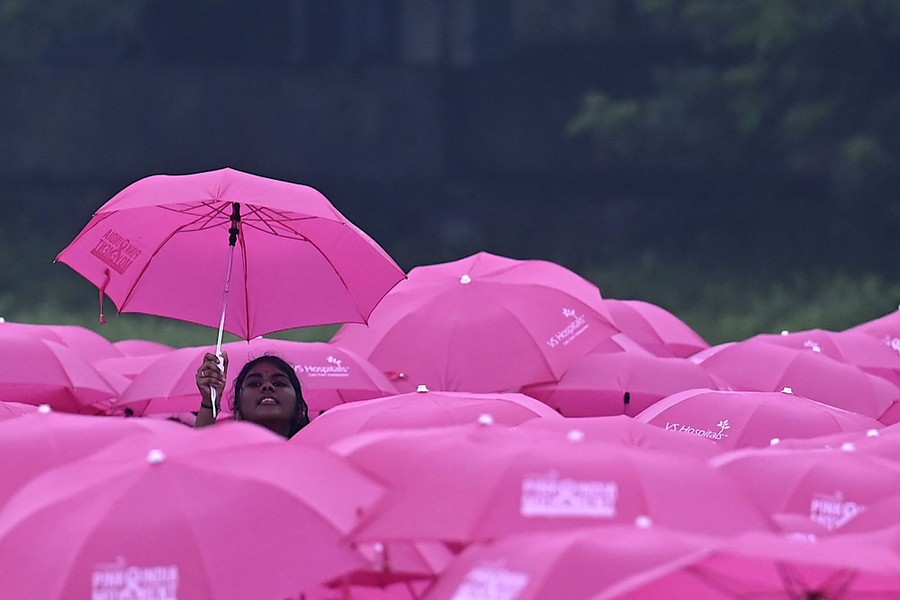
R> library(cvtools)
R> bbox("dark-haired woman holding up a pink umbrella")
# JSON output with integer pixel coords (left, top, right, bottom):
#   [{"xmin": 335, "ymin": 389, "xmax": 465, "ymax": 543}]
[{"xmin": 194, "ymin": 353, "xmax": 309, "ymax": 438}]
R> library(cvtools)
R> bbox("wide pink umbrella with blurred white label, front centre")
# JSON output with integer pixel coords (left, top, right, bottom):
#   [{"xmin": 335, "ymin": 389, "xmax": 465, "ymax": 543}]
[{"xmin": 344, "ymin": 426, "xmax": 771, "ymax": 546}]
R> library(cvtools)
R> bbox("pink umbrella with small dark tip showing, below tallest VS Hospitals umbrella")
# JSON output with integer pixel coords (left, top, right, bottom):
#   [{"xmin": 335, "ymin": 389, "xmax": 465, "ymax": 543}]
[{"xmin": 522, "ymin": 352, "xmax": 717, "ymax": 417}]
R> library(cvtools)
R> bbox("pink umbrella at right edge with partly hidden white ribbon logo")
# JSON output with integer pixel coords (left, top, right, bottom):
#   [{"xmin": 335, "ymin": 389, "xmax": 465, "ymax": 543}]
[{"xmin": 710, "ymin": 448, "xmax": 900, "ymax": 533}]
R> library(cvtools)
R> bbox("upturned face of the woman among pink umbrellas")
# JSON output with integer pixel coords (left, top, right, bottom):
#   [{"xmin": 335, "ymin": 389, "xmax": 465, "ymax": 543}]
[{"xmin": 241, "ymin": 361, "xmax": 297, "ymax": 423}]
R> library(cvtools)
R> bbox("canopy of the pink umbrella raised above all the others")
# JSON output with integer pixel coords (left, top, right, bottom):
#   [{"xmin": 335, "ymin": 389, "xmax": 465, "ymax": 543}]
[{"xmin": 57, "ymin": 168, "xmax": 404, "ymax": 339}]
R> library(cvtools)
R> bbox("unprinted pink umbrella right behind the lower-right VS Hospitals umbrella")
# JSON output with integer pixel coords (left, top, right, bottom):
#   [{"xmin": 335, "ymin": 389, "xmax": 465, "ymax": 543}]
[{"xmin": 700, "ymin": 341, "xmax": 900, "ymax": 419}]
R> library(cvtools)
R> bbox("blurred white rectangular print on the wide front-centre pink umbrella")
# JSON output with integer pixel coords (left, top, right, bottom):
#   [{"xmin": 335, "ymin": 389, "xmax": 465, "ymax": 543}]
[{"xmin": 520, "ymin": 473, "xmax": 619, "ymax": 518}]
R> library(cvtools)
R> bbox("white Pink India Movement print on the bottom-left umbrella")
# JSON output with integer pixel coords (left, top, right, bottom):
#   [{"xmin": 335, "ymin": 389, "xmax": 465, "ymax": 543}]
[{"xmin": 91, "ymin": 556, "xmax": 178, "ymax": 600}]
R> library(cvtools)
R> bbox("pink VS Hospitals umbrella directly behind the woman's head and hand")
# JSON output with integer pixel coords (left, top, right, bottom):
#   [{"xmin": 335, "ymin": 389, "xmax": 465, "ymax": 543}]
[{"xmin": 113, "ymin": 338, "xmax": 397, "ymax": 418}]
